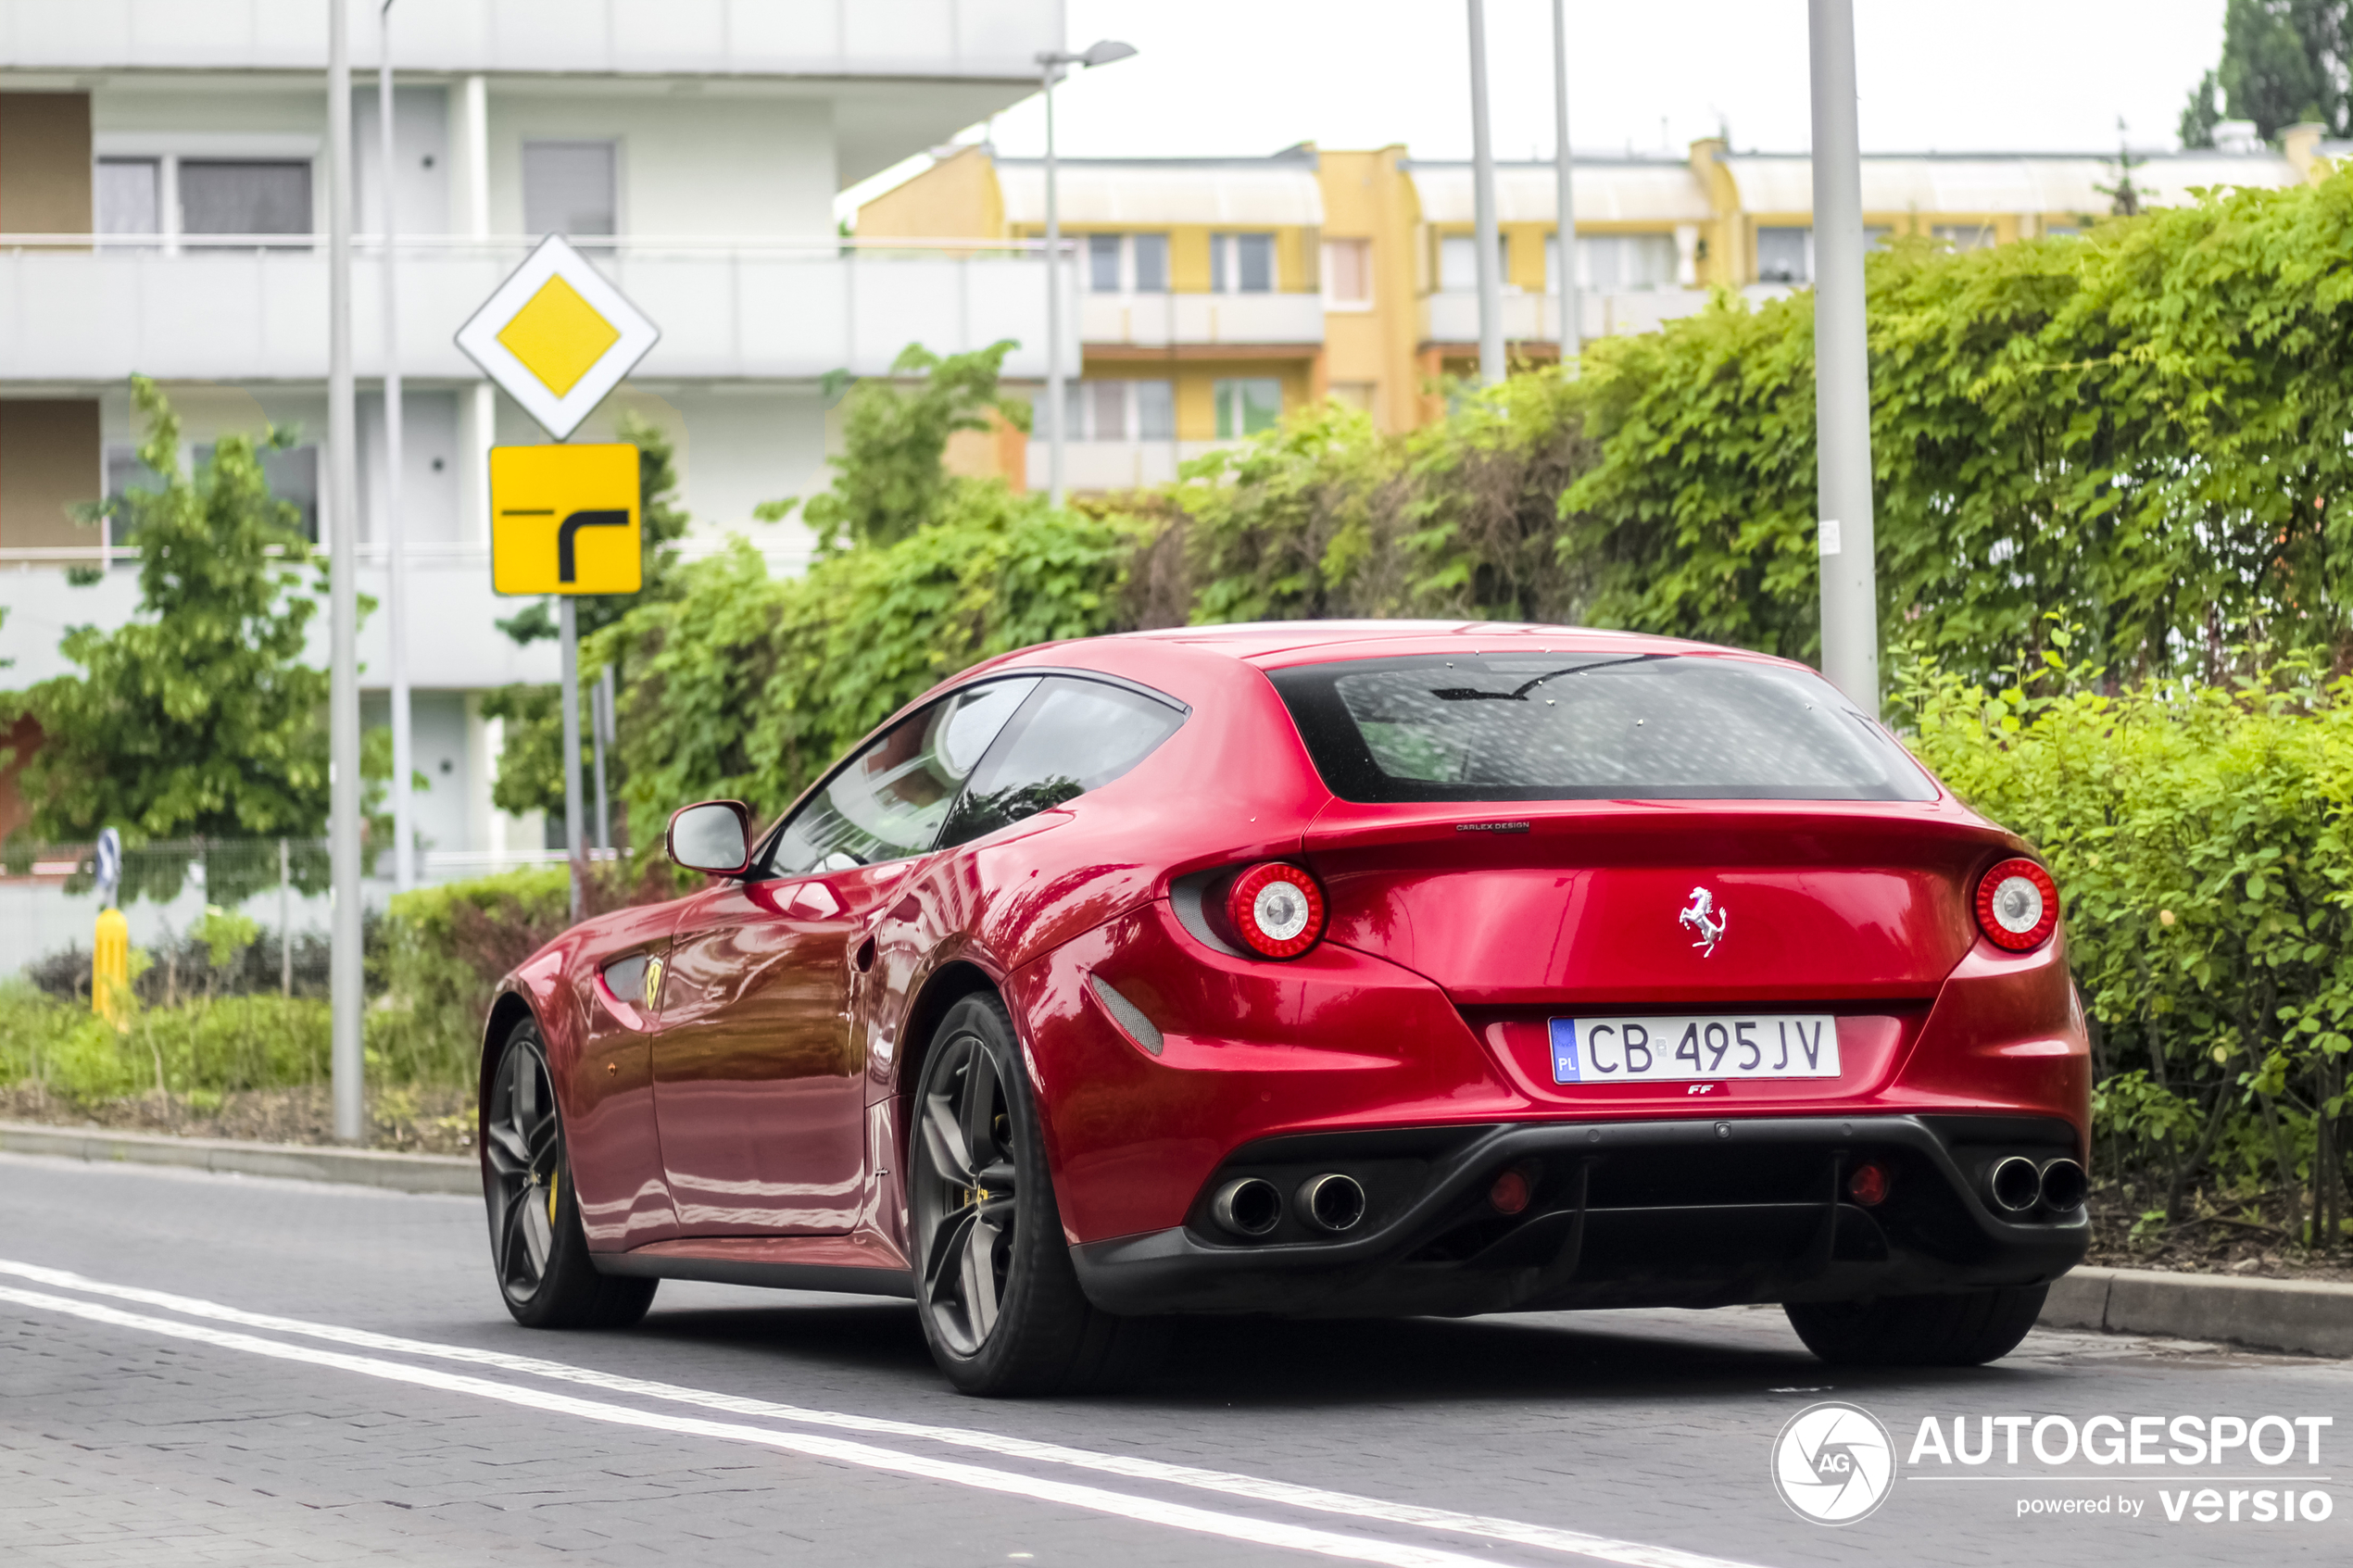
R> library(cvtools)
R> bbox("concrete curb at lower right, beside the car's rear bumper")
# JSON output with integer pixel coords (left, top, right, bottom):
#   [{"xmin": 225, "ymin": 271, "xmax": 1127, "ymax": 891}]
[{"xmin": 2038, "ymin": 1270, "xmax": 2353, "ymax": 1357}]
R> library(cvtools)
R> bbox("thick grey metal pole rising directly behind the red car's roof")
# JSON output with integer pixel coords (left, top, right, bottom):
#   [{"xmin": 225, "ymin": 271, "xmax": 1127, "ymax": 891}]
[{"xmin": 1807, "ymin": 0, "xmax": 1880, "ymax": 717}]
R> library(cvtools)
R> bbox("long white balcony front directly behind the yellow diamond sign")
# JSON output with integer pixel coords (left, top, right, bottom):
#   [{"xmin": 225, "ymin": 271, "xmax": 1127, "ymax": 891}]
[{"xmin": 0, "ymin": 235, "xmax": 1077, "ymax": 383}]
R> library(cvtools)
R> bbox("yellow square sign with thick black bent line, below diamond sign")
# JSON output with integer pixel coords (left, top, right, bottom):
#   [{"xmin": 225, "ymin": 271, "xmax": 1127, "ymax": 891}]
[{"xmin": 489, "ymin": 445, "xmax": 642, "ymax": 593}]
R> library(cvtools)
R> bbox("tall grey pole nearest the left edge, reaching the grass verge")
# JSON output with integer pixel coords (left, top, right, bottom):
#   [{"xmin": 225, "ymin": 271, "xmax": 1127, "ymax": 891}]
[{"xmin": 327, "ymin": 0, "xmax": 367, "ymax": 1143}]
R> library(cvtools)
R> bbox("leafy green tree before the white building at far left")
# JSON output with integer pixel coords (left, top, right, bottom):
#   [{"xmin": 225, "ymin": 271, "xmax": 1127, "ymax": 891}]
[{"xmin": 5, "ymin": 376, "xmax": 327, "ymax": 865}]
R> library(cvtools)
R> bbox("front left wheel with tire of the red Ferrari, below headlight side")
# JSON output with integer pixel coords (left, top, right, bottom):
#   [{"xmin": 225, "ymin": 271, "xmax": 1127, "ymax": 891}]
[{"xmin": 483, "ymin": 1018, "xmax": 661, "ymax": 1328}]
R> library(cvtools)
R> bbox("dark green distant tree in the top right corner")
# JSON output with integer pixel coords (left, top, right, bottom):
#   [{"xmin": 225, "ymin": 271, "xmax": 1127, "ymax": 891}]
[{"xmin": 2182, "ymin": 0, "xmax": 2353, "ymax": 148}]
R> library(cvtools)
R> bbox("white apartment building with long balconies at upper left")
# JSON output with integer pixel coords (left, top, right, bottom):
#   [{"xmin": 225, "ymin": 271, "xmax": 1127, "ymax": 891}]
[{"xmin": 0, "ymin": 0, "xmax": 1076, "ymax": 870}]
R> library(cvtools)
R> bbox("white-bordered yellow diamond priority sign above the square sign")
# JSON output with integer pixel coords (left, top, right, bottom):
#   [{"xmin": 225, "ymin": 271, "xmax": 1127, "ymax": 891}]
[{"xmin": 457, "ymin": 235, "xmax": 661, "ymax": 442}]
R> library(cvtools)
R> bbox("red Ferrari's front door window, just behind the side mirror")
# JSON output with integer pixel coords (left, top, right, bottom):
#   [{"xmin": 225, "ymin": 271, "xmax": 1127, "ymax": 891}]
[{"xmin": 765, "ymin": 677, "xmax": 1038, "ymax": 877}]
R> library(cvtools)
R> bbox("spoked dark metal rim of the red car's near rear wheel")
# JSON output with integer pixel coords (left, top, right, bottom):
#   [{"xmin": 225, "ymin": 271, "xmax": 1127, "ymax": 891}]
[{"xmin": 913, "ymin": 1035, "xmax": 1019, "ymax": 1357}]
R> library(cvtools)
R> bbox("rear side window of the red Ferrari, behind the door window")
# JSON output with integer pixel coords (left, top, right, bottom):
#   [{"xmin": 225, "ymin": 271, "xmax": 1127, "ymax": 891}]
[{"xmin": 938, "ymin": 674, "xmax": 1184, "ymax": 844}]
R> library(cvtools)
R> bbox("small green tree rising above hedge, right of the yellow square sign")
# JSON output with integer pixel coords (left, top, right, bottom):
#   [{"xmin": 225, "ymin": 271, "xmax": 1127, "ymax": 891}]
[{"xmin": 799, "ymin": 339, "xmax": 1031, "ymax": 555}]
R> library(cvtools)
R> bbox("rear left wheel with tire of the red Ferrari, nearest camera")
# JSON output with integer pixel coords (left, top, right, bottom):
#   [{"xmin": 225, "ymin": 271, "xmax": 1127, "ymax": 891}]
[{"xmin": 908, "ymin": 995, "xmax": 1164, "ymax": 1397}]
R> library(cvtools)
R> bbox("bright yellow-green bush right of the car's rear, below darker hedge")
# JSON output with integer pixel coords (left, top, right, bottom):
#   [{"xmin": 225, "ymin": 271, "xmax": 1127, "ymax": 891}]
[{"xmin": 1899, "ymin": 625, "xmax": 2353, "ymax": 1239}]
